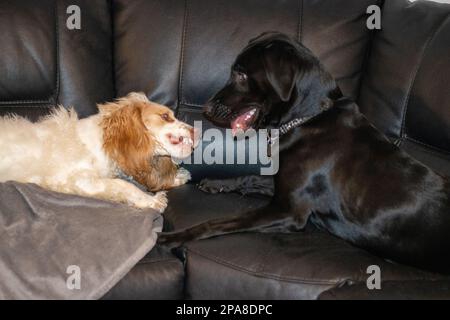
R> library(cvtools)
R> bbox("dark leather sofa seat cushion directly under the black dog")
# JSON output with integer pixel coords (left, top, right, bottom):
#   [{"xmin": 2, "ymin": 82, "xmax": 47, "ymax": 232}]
[{"xmin": 164, "ymin": 185, "xmax": 450, "ymax": 299}]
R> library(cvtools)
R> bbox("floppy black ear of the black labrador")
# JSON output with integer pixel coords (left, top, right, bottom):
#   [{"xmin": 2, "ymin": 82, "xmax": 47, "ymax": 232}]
[{"xmin": 263, "ymin": 42, "xmax": 299, "ymax": 102}]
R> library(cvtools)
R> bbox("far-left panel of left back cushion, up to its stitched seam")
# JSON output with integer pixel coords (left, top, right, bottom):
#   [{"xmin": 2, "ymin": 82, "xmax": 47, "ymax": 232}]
[{"xmin": 0, "ymin": 0, "xmax": 57, "ymax": 104}]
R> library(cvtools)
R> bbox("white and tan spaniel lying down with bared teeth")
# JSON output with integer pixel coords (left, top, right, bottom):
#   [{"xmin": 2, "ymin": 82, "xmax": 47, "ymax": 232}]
[{"xmin": 0, "ymin": 93, "xmax": 198, "ymax": 212}]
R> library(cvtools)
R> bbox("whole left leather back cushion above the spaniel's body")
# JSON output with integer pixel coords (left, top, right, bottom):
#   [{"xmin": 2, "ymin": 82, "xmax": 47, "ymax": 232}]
[{"xmin": 0, "ymin": 0, "xmax": 114, "ymax": 120}]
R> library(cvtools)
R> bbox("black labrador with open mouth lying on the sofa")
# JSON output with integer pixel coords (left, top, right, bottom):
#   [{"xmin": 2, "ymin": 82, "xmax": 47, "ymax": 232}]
[{"xmin": 158, "ymin": 33, "xmax": 450, "ymax": 272}]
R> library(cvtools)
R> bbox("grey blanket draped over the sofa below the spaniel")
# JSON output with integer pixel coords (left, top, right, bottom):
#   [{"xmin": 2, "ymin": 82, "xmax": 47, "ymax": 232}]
[{"xmin": 0, "ymin": 182, "xmax": 162, "ymax": 299}]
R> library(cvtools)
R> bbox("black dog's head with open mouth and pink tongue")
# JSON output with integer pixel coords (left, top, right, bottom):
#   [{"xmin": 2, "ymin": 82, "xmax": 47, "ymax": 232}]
[{"xmin": 204, "ymin": 32, "xmax": 340, "ymax": 132}]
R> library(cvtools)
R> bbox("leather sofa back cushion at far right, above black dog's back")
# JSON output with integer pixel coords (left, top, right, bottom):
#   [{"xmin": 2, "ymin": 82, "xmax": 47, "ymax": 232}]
[{"xmin": 359, "ymin": 0, "xmax": 450, "ymax": 175}]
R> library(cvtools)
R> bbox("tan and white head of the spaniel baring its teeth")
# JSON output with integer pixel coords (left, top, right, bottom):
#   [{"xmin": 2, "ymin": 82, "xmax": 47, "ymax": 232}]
[{"xmin": 98, "ymin": 92, "xmax": 199, "ymax": 176}]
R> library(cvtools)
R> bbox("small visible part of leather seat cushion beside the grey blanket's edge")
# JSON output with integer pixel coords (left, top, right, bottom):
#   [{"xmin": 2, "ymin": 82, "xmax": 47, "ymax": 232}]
[{"xmin": 103, "ymin": 246, "xmax": 184, "ymax": 300}]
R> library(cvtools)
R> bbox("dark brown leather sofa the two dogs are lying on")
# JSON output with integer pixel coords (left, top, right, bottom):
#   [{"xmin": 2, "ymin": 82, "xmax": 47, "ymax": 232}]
[{"xmin": 0, "ymin": 0, "xmax": 450, "ymax": 299}]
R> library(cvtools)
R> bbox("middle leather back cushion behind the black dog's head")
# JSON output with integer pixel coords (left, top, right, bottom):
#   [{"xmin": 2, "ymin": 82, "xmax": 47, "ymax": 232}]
[{"xmin": 113, "ymin": 0, "xmax": 380, "ymax": 178}]
